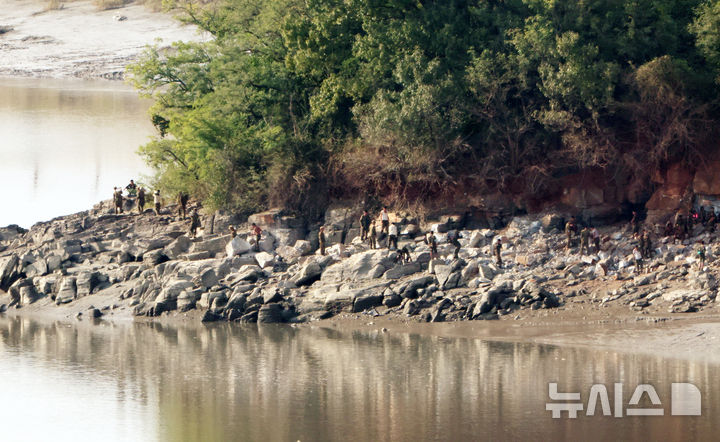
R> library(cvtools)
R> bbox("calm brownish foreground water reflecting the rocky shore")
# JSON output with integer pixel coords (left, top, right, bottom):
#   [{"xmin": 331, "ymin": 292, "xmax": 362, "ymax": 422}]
[{"xmin": 0, "ymin": 317, "xmax": 720, "ymax": 441}]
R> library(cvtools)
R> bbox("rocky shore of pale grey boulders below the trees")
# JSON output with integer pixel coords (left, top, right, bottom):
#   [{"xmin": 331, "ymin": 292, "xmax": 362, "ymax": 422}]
[{"xmin": 0, "ymin": 197, "xmax": 718, "ymax": 323}]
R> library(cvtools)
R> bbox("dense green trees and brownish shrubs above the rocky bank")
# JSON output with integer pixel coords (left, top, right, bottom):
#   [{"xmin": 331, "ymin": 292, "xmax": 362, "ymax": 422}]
[{"xmin": 130, "ymin": 0, "xmax": 720, "ymax": 214}]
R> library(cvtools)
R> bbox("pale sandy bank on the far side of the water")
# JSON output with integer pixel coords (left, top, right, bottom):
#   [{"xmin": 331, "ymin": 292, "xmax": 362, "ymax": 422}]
[{"xmin": 0, "ymin": 0, "xmax": 208, "ymax": 79}]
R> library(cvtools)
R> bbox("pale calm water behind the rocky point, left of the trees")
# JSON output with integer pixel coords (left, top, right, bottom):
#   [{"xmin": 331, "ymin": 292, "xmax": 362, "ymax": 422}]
[{"xmin": 0, "ymin": 78, "xmax": 153, "ymax": 227}]
